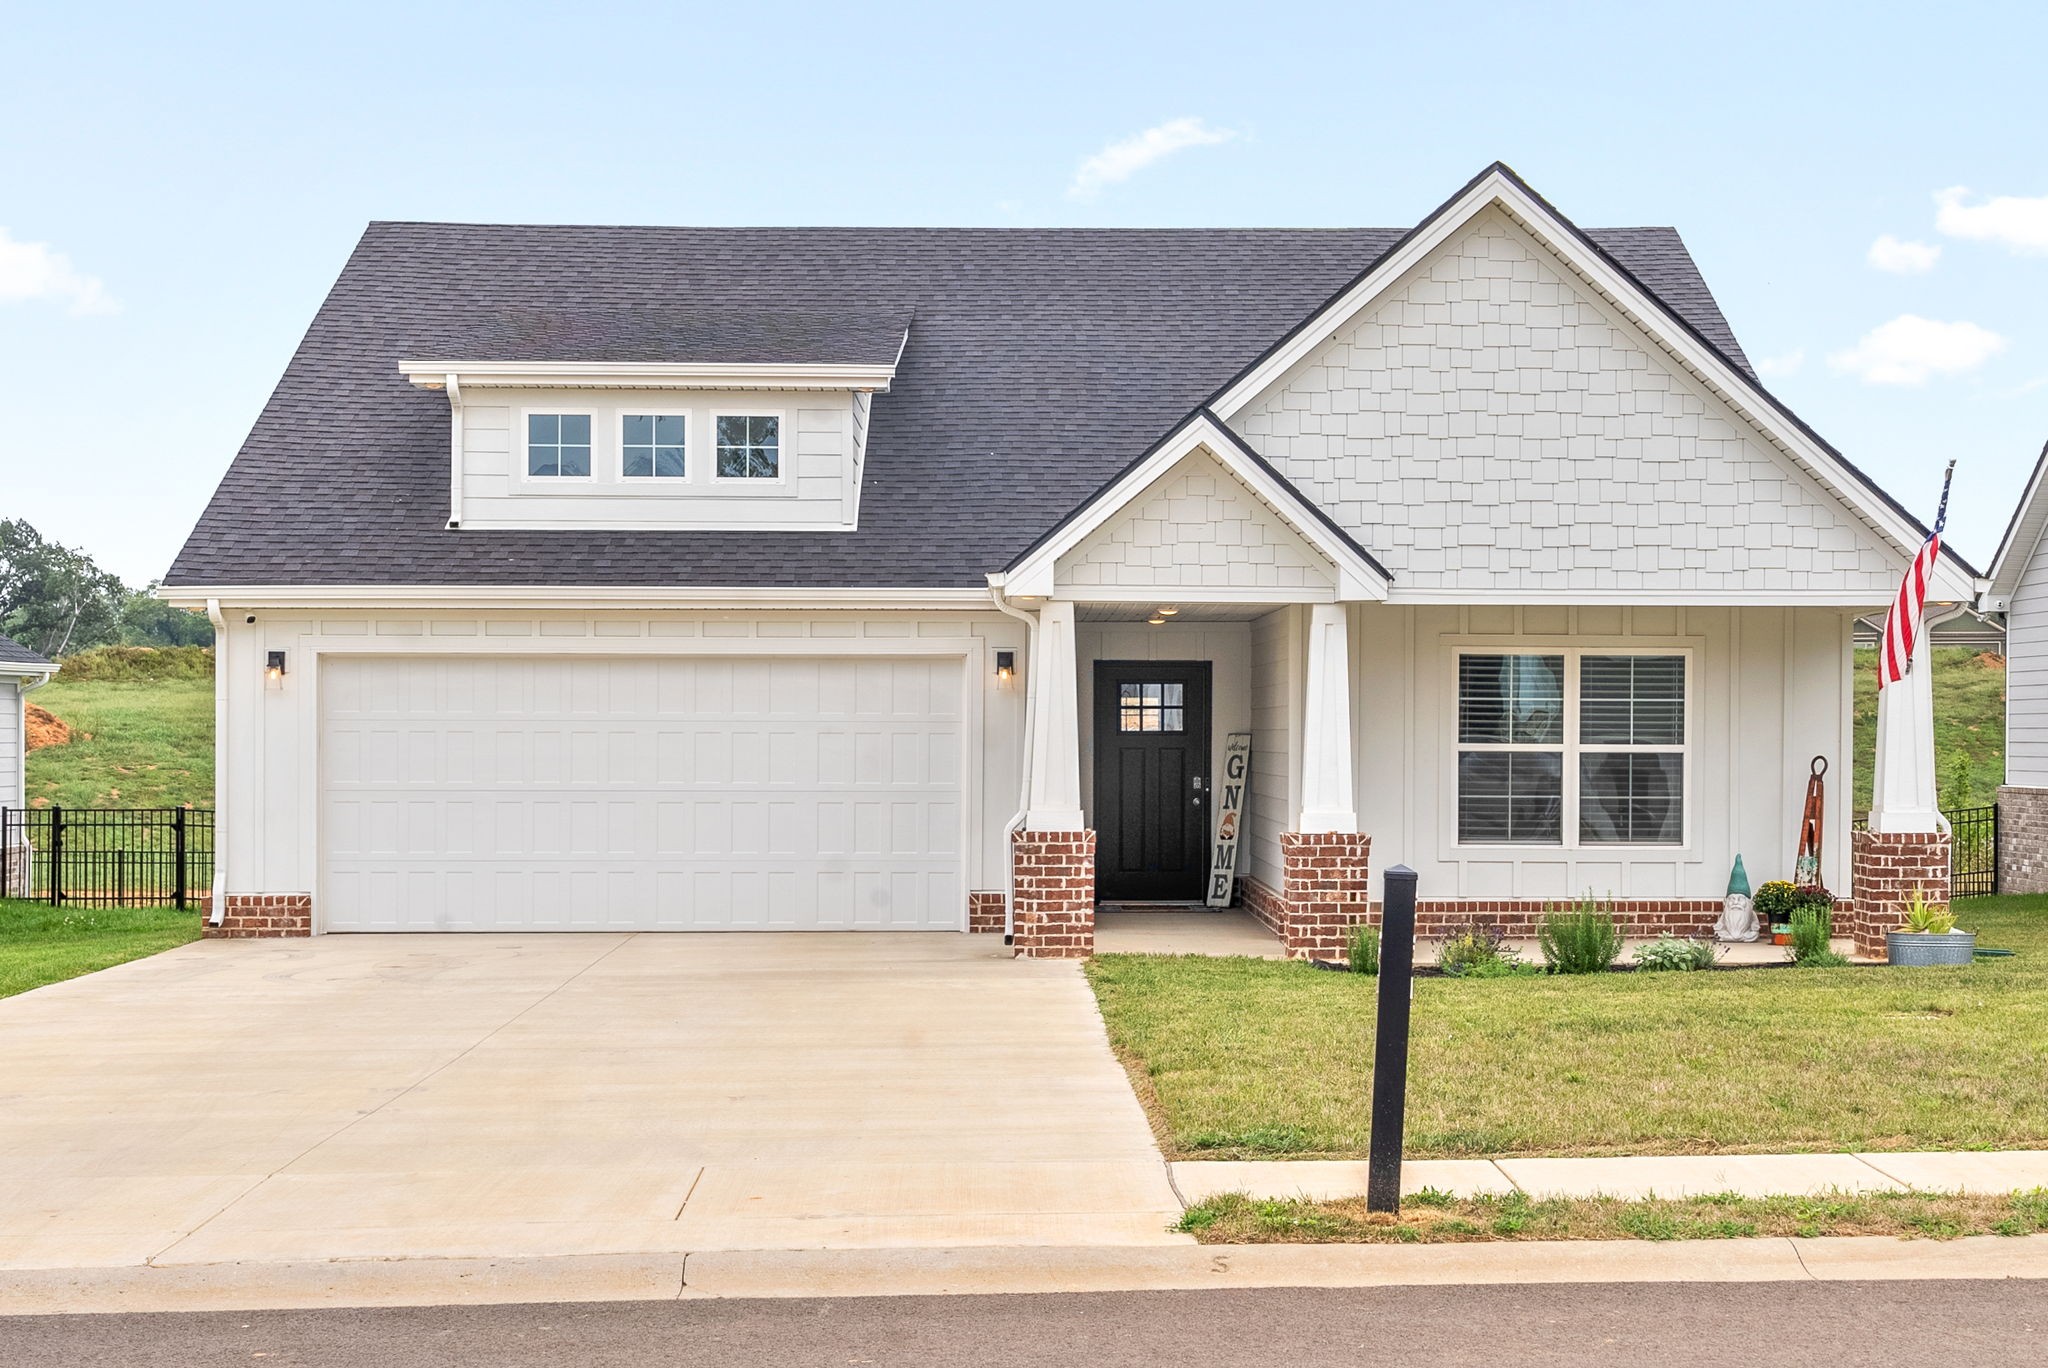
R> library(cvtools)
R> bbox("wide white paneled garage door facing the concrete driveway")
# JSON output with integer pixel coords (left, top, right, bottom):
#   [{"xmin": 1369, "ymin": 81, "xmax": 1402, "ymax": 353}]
[{"xmin": 319, "ymin": 655, "xmax": 967, "ymax": 932}]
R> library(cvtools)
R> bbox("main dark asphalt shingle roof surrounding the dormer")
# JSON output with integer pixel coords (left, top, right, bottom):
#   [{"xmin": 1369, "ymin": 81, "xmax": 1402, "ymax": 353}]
[{"xmin": 166, "ymin": 223, "xmax": 1747, "ymax": 588}]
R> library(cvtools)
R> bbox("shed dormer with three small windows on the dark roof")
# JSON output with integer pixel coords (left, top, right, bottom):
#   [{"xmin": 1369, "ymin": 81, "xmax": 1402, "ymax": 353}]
[{"xmin": 399, "ymin": 309, "xmax": 909, "ymax": 532}]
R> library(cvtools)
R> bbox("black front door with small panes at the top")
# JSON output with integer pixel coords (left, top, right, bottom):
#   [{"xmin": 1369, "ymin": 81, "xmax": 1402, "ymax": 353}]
[{"xmin": 1096, "ymin": 659, "xmax": 1210, "ymax": 901}]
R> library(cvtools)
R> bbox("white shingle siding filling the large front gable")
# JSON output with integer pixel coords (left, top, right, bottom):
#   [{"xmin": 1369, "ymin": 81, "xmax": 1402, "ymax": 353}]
[{"xmin": 1235, "ymin": 211, "xmax": 1905, "ymax": 602}]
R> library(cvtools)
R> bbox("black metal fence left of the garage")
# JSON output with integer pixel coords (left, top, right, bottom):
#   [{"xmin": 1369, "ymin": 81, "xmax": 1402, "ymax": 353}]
[{"xmin": 0, "ymin": 807, "xmax": 213, "ymax": 907}]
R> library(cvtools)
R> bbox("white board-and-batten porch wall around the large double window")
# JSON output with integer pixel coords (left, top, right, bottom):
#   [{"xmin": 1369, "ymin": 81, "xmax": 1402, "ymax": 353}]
[{"xmin": 1351, "ymin": 604, "xmax": 1853, "ymax": 899}]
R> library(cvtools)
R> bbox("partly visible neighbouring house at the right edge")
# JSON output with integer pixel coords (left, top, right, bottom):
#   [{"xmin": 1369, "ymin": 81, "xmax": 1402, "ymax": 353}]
[{"xmin": 1976, "ymin": 446, "xmax": 2048, "ymax": 893}]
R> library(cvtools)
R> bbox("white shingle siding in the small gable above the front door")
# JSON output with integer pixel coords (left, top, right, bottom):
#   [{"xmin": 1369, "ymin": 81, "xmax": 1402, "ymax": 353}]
[{"xmin": 1055, "ymin": 451, "xmax": 1335, "ymax": 590}]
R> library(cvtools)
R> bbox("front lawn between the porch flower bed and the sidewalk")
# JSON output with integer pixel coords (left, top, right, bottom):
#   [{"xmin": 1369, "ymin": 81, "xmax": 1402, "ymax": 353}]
[{"xmin": 1087, "ymin": 897, "xmax": 2048, "ymax": 1159}]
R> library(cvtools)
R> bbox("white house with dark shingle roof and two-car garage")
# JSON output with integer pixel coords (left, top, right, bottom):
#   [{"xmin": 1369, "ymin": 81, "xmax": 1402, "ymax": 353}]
[{"xmin": 166, "ymin": 166, "xmax": 1976, "ymax": 956}]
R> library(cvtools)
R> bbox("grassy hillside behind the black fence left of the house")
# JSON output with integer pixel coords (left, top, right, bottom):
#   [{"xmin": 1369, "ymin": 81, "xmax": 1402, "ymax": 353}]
[{"xmin": 29, "ymin": 678, "xmax": 213, "ymax": 807}]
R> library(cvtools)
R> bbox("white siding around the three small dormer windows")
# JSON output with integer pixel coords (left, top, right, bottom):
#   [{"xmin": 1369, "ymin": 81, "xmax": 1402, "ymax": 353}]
[{"xmin": 461, "ymin": 389, "xmax": 866, "ymax": 532}]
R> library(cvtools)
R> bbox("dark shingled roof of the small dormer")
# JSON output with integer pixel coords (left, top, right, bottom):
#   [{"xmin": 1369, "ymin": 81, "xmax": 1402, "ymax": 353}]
[{"xmin": 408, "ymin": 305, "xmax": 909, "ymax": 367}]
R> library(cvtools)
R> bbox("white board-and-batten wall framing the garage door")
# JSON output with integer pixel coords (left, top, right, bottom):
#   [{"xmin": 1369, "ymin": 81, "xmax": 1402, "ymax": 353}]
[{"xmin": 217, "ymin": 608, "xmax": 1030, "ymax": 920}]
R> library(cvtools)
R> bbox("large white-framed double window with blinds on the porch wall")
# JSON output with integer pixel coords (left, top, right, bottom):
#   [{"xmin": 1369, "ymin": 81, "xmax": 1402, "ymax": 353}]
[{"xmin": 1458, "ymin": 649, "xmax": 1688, "ymax": 846}]
